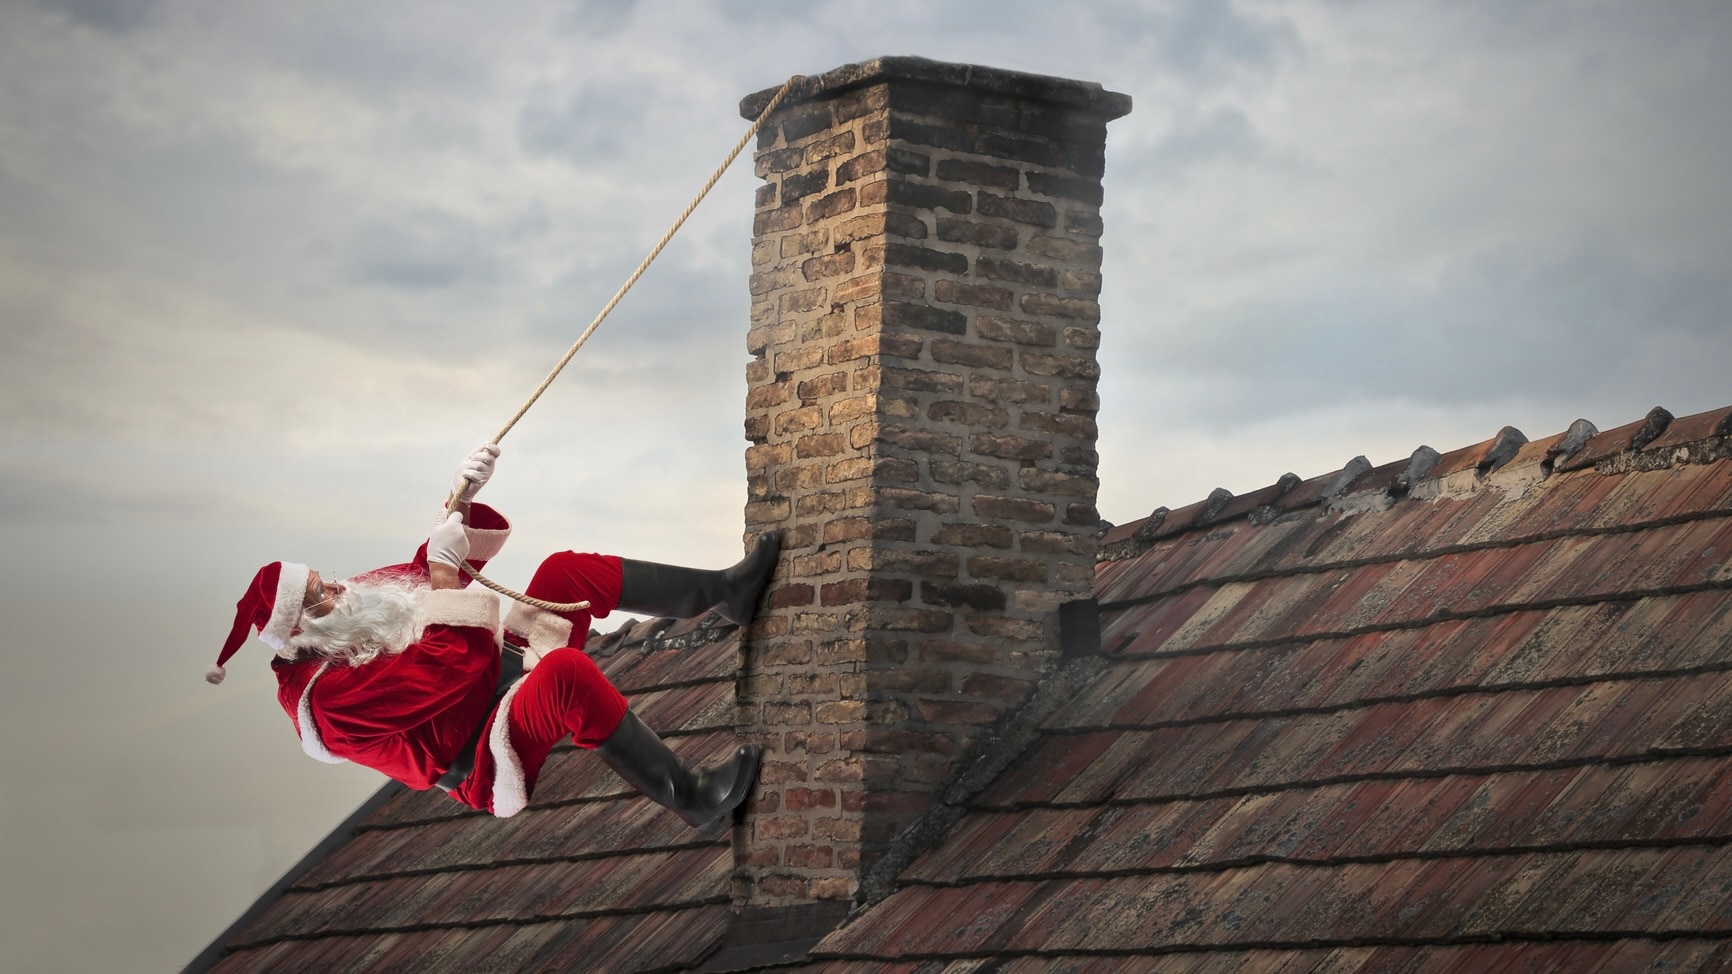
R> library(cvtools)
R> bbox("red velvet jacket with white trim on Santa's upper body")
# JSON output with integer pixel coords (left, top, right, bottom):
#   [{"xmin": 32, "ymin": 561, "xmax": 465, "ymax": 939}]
[{"xmin": 270, "ymin": 504, "xmax": 511, "ymax": 789}]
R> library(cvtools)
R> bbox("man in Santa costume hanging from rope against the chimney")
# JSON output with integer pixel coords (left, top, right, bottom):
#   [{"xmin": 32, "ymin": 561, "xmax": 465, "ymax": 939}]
[{"xmin": 206, "ymin": 445, "xmax": 778, "ymax": 828}]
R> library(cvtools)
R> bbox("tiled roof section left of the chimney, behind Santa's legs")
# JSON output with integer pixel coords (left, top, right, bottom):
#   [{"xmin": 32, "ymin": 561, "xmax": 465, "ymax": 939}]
[{"xmin": 201, "ymin": 615, "xmax": 740, "ymax": 974}]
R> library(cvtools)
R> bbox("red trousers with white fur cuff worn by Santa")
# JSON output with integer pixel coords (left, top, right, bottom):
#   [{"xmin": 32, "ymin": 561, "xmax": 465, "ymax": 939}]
[{"xmin": 450, "ymin": 551, "xmax": 627, "ymax": 811}]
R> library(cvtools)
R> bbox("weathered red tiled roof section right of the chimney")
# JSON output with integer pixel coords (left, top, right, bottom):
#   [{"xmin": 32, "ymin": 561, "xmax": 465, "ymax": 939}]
[{"xmin": 802, "ymin": 400, "xmax": 1732, "ymax": 972}]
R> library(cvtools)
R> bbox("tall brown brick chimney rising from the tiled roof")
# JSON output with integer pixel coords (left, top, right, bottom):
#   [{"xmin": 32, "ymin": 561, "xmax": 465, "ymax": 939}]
[{"xmin": 736, "ymin": 57, "xmax": 1131, "ymax": 908}]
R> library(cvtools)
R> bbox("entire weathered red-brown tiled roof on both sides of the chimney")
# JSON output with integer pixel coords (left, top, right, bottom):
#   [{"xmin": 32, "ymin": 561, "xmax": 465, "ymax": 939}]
[{"xmin": 193, "ymin": 398, "xmax": 1732, "ymax": 974}]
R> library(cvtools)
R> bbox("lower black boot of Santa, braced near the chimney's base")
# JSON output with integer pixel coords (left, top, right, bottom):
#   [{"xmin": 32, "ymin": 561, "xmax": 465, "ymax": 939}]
[{"xmin": 596, "ymin": 711, "xmax": 764, "ymax": 830}]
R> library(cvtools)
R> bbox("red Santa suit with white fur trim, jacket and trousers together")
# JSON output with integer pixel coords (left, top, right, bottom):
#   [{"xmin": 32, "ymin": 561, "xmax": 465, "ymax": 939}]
[{"xmin": 272, "ymin": 504, "xmax": 627, "ymax": 816}]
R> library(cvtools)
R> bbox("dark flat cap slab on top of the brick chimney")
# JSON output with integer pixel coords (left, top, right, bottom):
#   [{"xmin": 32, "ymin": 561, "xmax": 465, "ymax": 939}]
[{"xmin": 740, "ymin": 55, "xmax": 1131, "ymax": 121}]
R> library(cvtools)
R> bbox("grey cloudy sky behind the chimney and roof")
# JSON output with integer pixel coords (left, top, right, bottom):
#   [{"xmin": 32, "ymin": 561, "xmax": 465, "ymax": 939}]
[{"xmin": 0, "ymin": 0, "xmax": 1732, "ymax": 972}]
